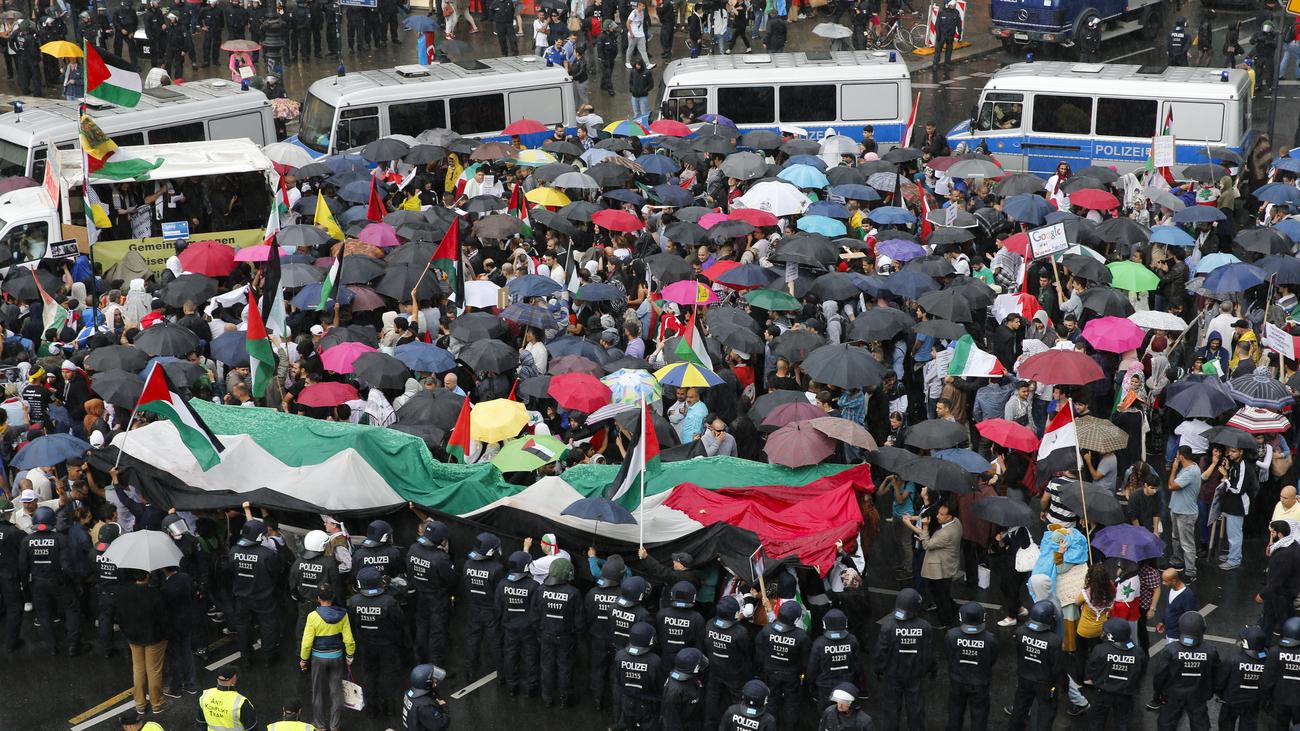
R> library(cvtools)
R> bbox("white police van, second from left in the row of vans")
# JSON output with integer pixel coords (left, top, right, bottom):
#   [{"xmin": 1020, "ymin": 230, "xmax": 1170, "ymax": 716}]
[{"xmin": 289, "ymin": 56, "xmax": 577, "ymax": 156}]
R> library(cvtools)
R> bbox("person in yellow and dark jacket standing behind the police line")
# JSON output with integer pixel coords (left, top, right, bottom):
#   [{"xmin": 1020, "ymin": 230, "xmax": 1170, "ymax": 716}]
[{"xmin": 298, "ymin": 584, "xmax": 356, "ymax": 731}]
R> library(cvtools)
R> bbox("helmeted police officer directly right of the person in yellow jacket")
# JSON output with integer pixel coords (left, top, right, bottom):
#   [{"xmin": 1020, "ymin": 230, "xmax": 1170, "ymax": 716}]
[{"xmin": 347, "ymin": 566, "xmax": 406, "ymax": 715}]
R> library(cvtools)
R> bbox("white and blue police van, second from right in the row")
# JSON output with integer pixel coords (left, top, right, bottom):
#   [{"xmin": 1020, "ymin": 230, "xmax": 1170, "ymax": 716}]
[{"xmin": 653, "ymin": 51, "xmax": 911, "ymax": 143}]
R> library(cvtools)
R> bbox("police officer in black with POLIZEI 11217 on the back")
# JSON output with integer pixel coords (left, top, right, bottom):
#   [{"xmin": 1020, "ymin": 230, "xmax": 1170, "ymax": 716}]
[{"xmin": 529, "ymin": 557, "xmax": 582, "ymax": 708}]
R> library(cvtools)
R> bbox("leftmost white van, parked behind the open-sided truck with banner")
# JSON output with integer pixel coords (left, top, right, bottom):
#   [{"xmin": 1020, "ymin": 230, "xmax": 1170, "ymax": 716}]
[{"xmin": 0, "ymin": 79, "xmax": 276, "ymax": 181}]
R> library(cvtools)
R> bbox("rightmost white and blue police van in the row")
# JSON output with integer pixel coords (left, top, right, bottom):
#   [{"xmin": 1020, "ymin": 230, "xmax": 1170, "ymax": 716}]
[{"xmin": 948, "ymin": 61, "xmax": 1256, "ymax": 176}]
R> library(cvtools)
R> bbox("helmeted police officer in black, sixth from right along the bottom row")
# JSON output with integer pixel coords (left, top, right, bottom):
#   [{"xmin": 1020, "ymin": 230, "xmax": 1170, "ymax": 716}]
[{"xmin": 944, "ymin": 601, "xmax": 997, "ymax": 731}]
